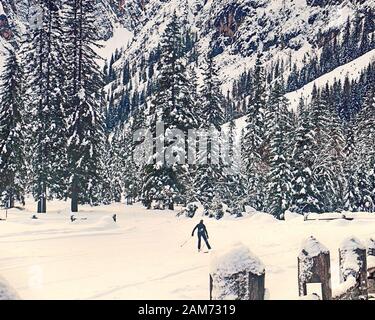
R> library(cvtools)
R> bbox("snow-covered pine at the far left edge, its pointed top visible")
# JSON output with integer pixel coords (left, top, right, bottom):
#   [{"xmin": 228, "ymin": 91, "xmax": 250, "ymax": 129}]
[{"xmin": 0, "ymin": 49, "xmax": 26, "ymax": 208}]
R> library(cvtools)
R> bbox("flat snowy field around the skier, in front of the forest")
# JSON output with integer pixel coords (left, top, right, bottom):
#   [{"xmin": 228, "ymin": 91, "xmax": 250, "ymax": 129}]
[{"xmin": 0, "ymin": 202, "xmax": 375, "ymax": 299}]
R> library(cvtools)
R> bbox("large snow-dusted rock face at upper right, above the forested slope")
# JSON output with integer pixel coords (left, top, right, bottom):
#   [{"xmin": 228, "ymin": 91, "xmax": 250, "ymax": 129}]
[{"xmin": 106, "ymin": 0, "xmax": 375, "ymax": 89}]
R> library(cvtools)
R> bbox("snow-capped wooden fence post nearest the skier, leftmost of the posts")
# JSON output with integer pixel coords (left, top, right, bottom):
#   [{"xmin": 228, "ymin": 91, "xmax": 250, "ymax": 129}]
[{"xmin": 210, "ymin": 244, "xmax": 265, "ymax": 300}]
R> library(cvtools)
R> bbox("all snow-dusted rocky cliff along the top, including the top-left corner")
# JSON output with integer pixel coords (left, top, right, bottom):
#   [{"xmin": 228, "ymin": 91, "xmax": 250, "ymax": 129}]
[{"xmin": 0, "ymin": 0, "xmax": 375, "ymax": 90}]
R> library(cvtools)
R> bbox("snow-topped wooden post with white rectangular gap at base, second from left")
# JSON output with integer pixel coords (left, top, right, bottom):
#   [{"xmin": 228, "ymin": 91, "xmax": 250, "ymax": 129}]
[{"xmin": 298, "ymin": 236, "xmax": 332, "ymax": 300}]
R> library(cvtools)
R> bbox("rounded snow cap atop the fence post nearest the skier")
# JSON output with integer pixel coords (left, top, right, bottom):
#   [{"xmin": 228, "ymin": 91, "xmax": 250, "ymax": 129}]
[{"xmin": 210, "ymin": 243, "xmax": 265, "ymax": 275}]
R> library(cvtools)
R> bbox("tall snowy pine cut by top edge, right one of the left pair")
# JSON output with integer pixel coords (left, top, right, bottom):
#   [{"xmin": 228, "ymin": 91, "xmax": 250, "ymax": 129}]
[{"xmin": 65, "ymin": 0, "xmax": 105, "ymax": 212}]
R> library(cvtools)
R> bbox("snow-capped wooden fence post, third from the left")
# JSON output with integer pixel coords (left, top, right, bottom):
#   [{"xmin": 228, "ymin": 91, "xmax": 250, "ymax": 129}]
[{"xmin": 339, "ymin": 237, "xmax": 368, "ymax": 300}]
